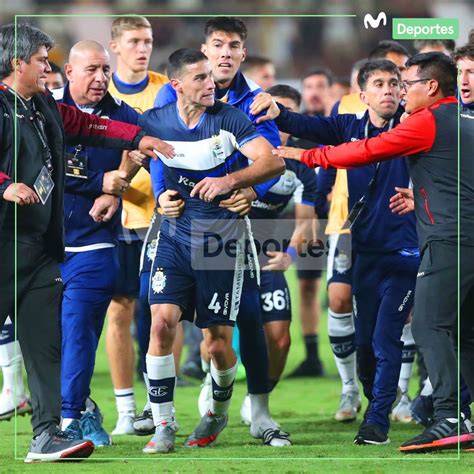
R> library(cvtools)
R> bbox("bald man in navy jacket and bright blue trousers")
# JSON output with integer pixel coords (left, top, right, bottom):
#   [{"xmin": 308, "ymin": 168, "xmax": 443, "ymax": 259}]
[{"xmin": 53, "ymin": 41, "xmax": 138, "ymax": 446}]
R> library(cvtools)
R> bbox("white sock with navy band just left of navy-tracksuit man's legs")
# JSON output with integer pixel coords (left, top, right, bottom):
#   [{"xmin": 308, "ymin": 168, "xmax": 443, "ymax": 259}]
[{"xmin": 328, "ymin": 309, "xmax": 359, "ymax": 393}]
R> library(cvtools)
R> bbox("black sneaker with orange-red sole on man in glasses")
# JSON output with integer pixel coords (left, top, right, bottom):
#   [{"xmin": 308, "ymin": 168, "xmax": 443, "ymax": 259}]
[{"xmin": 400, "ymin": 418, "xmax": 473, "ymax": 453}]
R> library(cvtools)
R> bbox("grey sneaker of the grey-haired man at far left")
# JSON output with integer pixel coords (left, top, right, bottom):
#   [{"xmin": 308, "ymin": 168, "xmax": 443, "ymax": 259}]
[{"xmin": 25, "ymin": 428, "xmax": 94, "ymax": 463}]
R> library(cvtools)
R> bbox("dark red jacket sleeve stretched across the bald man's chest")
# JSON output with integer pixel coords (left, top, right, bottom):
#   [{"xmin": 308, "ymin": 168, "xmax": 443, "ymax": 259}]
[{"xmin": 58, "ymin": 103, "xmax": 144, "ymax": 149}]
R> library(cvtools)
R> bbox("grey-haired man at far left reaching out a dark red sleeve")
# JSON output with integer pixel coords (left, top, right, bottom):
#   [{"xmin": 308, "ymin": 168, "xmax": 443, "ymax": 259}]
[{"xmin": 0, "ymin": 25, "xmax": 172, "ymax": 462}]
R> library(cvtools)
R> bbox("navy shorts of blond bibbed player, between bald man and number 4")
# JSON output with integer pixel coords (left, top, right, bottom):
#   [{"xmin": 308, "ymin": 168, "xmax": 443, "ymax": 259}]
[{"xmin": 114, "ymin": 240, "xmax": 142, "ymax": 298}]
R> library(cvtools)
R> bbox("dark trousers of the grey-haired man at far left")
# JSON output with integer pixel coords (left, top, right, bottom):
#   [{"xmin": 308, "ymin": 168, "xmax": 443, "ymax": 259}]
[{"xmin": 0, "ymin": 237, "xmax": 62, "ymax": 436}]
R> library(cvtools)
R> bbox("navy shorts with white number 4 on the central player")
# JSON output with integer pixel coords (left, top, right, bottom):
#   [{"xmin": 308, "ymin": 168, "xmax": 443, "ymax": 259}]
[{"xmin": 148, "ymin": 233, "xmax": 245, "ymax": 328}]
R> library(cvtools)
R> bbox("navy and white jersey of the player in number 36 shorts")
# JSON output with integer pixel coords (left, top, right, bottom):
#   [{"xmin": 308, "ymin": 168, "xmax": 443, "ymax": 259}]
[{"xmin": 250, "ymin": 158, "xmax": 316, "ymax": 219}]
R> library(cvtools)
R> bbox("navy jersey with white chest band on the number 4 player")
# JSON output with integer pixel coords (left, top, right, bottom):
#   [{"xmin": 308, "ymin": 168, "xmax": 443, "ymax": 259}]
[{"xmin": 139, "ymin": 102, "xmax": 259, "ymax": 245}]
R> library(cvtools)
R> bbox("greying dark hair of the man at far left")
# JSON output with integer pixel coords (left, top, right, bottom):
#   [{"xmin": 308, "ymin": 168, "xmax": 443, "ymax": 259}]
[{"xmin": 0, "ymin": 23, "xmax": 54, "ymax": 79}]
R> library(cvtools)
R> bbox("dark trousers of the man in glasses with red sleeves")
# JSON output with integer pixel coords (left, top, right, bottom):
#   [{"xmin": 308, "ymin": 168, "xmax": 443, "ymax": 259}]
[{"xmin": 412, "ymin": 242, "xmax": 474, "ymax": 419}]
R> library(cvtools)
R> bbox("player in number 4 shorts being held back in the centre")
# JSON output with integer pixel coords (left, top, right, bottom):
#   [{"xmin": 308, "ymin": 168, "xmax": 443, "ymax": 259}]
[{"xmin": 140, "ymin": 49, "xmax": 284, "ymax": 453}]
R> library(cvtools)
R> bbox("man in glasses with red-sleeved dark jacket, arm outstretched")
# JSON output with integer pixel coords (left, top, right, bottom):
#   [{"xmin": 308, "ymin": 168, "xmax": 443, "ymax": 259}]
[{"xmin": 278, "ymin": 53, "xmax": 474, "ymax": 452}]
